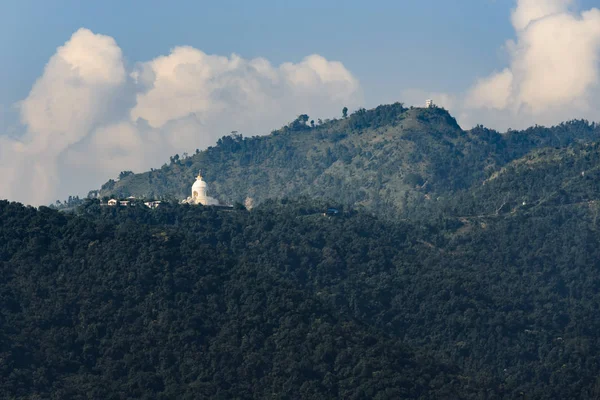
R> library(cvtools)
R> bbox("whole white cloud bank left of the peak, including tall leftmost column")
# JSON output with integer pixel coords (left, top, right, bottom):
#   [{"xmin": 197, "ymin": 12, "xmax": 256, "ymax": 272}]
[{"xmin": 0, "ymin": 28, "xmax": 362, "ymax": 205}]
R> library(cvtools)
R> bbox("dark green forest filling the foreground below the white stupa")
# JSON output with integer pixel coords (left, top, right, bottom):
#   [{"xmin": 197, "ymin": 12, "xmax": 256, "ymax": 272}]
[{"xmin": 0, "ymin": 194, "xmax": 600, "ymax": 399}]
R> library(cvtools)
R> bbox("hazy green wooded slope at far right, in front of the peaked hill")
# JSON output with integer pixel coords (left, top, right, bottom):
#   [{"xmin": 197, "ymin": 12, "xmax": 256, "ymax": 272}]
[{"xmin": 412, "ymin": 143, "xmax": 600, "ymax": 222}]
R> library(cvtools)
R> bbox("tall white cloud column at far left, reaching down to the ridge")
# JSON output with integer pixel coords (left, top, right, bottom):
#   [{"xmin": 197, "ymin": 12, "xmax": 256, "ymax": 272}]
[{"xmin": 0, "ymin": 29, "xmax": 126, "ymax": 204}]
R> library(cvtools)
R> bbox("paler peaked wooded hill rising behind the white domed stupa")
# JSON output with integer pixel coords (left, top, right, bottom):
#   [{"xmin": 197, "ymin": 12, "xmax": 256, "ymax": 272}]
[{"xmin": 94, "ymin": 103, "xmax": 600, "ymax": 213}]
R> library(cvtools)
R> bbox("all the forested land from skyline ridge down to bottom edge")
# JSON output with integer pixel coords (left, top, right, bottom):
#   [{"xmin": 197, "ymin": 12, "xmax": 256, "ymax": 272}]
[{"xmin": 7, "ymin": 103, "xmax": 600, "ymax": 400}]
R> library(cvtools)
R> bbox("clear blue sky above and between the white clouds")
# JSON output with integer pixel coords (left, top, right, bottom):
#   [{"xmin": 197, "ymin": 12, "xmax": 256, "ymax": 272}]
[{"xmin": 0, "ymin": 0, "xmax": 514, "ymax": 112}]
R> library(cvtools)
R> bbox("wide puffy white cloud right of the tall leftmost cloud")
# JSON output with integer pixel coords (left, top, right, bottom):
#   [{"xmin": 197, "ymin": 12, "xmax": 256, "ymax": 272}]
[{"xmin": 131, "ymin": 47, "xmax": 360, "ymax": 129}]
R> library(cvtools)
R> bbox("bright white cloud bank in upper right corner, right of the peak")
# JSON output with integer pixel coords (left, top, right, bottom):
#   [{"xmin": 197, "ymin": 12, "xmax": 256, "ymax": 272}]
[{"xmin": 408, "ymin": 0, "xmax": 600, "ymax": 129}]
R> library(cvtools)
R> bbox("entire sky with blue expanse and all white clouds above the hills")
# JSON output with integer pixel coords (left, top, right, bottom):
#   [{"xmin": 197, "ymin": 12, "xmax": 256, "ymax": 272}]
[{"xmin": 0, "ymin": 0, "xmax": 600, "ymax": 205}]
